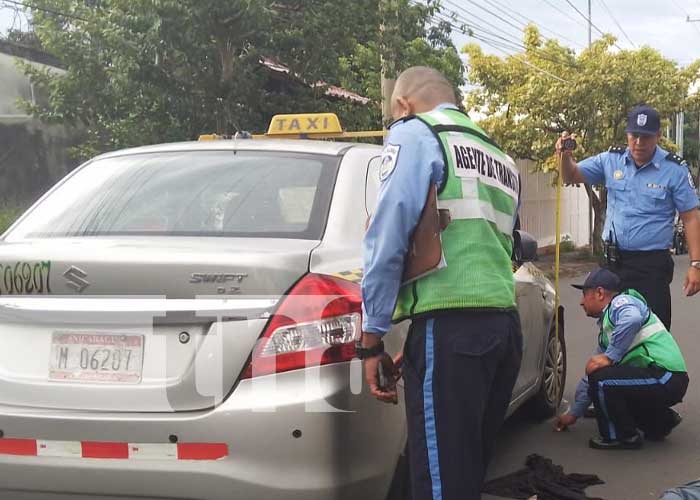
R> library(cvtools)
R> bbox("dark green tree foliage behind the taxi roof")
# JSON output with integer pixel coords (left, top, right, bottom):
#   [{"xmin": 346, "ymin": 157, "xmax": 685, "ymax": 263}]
[{"xmin": 13, "ymin": 0, "xmax": 463, "ymax": 157}]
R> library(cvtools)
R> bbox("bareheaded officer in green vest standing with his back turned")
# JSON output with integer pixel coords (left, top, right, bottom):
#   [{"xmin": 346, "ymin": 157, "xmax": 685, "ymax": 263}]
[{"xmin": 358, "ymin": 67, "xmax": 522, "ymax": 500}]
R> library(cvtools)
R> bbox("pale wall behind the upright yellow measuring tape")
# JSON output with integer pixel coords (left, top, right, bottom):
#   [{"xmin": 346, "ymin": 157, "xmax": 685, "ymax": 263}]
[{"xmin": 516, "ymin": 160, "xmax": 589, "ymax": 247}]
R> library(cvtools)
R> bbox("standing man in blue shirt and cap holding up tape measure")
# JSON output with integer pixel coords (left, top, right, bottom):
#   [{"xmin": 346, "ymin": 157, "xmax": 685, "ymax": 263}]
[{"xmin": 556, "ymin": 106, "xmax": 700, "ymax": 328}]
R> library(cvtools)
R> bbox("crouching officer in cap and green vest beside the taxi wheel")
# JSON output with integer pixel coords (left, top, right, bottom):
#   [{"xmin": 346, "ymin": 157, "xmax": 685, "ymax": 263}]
[{"xmin": 557, "ymin": 269, "xmax": 688, "ymax": 450}]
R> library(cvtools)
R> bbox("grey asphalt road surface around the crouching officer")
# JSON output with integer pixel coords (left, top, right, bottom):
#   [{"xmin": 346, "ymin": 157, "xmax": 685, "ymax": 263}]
[{"xmin": 483, "ymin": 255, "xmax": 700, "ymax": 500}]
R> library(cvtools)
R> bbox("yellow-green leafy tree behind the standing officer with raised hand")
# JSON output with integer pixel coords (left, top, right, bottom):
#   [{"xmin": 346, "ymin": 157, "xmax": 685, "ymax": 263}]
[{"xmin": 463, "ymin": 26, "xmax": 697, "ymax": 251}]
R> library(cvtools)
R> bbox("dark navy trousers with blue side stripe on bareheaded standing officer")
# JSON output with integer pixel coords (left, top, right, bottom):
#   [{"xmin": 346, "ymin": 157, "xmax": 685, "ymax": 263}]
[{"xmin": 403, "ymin": 310, "xmax": 522, "ymax": 500}]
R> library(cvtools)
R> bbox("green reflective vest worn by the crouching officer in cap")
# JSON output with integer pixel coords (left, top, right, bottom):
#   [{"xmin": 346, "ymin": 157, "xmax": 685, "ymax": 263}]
[{"xmin": 598, "ymin": 290, "xmax": 687, "ymax": 372}]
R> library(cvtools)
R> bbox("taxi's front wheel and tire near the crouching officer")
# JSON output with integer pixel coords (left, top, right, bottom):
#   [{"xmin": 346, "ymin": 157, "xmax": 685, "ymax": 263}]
[{"xmin": 524, "ymin": 322, "xmax": 566, "ymax": 419}]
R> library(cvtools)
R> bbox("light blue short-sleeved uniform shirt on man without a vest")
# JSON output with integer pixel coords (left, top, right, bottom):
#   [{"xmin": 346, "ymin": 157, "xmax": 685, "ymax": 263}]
[{"xmin": 579, "ymin": 146, "xmax": 698, "ymax": 250}]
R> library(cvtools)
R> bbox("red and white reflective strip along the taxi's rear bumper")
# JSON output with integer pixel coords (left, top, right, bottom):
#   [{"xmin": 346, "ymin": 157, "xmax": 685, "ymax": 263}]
[{"xmin": 0, "ymin": 438, "xmax": 228, "ymax": 460}]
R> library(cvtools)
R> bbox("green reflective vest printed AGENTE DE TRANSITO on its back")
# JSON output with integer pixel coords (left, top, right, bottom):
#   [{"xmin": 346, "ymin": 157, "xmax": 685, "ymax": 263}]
[{"xmin": 394, "ymin": 109, "xmax": 520, "ymax": 321}]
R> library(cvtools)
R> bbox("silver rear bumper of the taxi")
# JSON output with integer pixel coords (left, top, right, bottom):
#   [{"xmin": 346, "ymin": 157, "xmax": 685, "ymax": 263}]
[{"xmin": 0, "ymin": 363, "xmax": 406, "ymax": 500}]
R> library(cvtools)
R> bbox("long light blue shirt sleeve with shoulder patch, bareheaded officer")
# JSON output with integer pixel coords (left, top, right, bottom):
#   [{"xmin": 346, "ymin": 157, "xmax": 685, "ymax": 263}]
[{"xmin": 362, "ymin": 104, "xmax": 456, "ymax": 335}]
